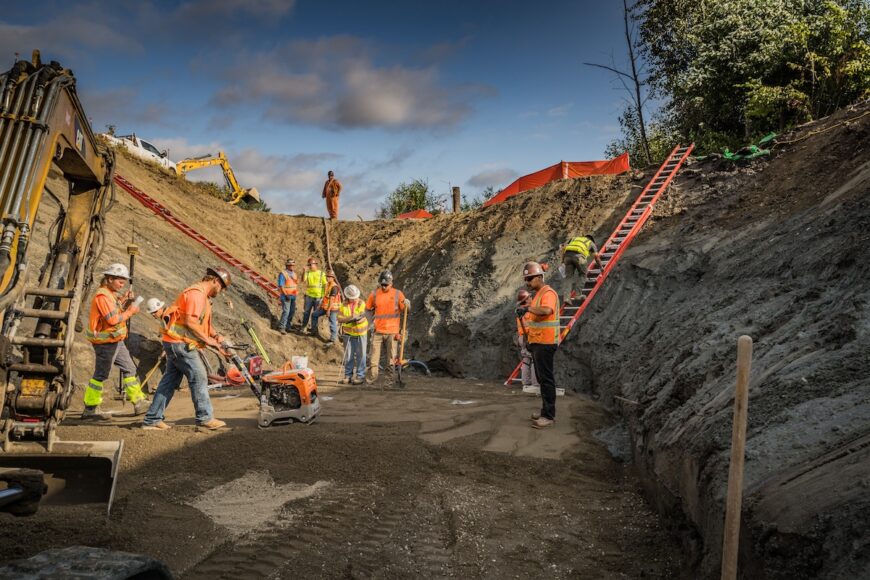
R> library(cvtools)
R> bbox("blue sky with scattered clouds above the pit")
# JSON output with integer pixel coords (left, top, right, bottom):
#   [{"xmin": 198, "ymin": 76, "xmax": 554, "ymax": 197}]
[{"xmin": 0, "ymin": 0, "xmax": 640, "ymax": 218}]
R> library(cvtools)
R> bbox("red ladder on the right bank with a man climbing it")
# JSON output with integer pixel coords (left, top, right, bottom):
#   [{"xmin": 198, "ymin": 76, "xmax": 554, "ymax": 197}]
[{"xmin": 504, "ymin": 143, "xmax": 695, "ymax": 385}]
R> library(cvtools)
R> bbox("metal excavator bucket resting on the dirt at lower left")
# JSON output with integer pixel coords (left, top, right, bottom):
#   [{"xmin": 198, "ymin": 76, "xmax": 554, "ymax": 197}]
[{"xmin": 0, "ymin": 441, "xmax": 124, "ymax": 513}]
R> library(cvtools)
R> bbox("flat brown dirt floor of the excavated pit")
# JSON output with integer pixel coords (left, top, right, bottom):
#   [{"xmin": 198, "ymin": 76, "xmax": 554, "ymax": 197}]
[{"xmin": 0, "ymin": 376, "xmax": 681, "ymax": 578}]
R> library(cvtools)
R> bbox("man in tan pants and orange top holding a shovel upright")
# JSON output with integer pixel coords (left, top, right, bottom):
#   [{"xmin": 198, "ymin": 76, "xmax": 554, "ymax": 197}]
[{"xmin": 366, "ymin": 270, "xmax": 411, "ymax": 381}]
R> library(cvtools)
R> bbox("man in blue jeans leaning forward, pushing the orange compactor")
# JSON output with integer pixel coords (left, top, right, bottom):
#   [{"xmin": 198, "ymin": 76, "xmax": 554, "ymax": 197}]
[{"xmin": 142, "ymin": 268, "xmax": 232, "ymax": 431}]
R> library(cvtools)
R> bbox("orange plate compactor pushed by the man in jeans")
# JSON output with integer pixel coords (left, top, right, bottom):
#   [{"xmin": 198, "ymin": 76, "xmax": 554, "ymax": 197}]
[{"xmin": 211, "ymin": 353, "xmax": 320, "ymax": 429}]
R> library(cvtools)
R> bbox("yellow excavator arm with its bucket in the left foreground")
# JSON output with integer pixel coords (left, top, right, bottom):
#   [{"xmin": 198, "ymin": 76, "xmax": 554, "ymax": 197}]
[{"xmin": 0, "ymin": 51, "xmax": 123, "ymax": 510}]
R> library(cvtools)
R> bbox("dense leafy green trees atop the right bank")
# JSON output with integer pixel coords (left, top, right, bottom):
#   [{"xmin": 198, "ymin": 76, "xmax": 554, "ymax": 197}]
[{"xmin": 621, "ymin": 0, "xmax": 870, "ymax": 150}]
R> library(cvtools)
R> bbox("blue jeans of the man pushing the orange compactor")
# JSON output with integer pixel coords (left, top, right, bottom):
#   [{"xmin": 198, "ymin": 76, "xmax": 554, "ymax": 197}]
[{"xmin": 144, "ymin": 342, "xmax": 213, "ymax": 425}]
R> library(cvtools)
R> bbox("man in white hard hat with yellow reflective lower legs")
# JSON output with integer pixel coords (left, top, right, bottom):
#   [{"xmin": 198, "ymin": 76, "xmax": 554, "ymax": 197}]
[{"xmin": 82, "ymin": 264, "xmax": 148, "ymax": 419}]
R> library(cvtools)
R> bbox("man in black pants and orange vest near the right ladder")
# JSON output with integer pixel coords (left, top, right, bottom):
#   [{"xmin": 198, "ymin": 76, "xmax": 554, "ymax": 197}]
[{"xmin": 516, "ymin": 262, "xmax": 559, "ymax": 429}]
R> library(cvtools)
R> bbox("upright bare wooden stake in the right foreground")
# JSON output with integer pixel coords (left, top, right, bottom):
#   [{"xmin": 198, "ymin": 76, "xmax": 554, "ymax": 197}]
[{"xmin": 722, "ymin": 335, "xmax": 752, "ymax": 580}]
